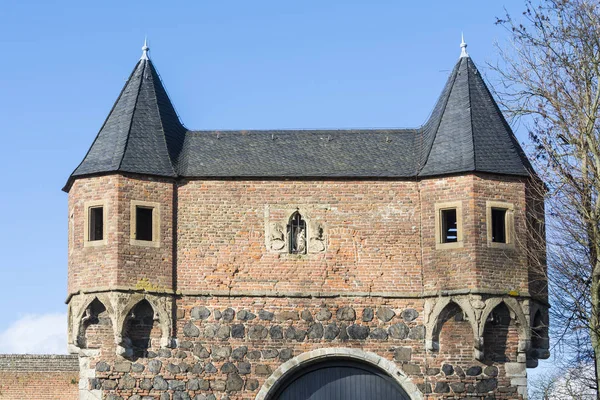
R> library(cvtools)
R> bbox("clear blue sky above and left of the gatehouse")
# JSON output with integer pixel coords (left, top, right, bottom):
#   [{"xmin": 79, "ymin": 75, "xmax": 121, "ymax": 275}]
[{"xmin": 0, "ymin": 0, "xmax": 540, "ymax": 352}]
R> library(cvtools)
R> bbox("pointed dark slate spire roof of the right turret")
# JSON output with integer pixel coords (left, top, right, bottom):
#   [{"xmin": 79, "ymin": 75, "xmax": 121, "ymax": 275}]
[{"xmin": 418, "ymin": 39, "xmax": 533, "ymax": 176}]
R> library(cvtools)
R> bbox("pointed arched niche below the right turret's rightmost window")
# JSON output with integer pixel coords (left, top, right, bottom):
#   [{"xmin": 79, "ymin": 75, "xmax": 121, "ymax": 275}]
[{"xmin": 479, "ymin": 298, "xmax": 530, "ymax": 362}]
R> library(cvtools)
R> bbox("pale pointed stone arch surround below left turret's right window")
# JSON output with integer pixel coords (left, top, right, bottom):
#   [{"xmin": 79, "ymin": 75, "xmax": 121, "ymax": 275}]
[{"xmin": 115, "ymin": 293, "xmax": 172, "ymax": 357}]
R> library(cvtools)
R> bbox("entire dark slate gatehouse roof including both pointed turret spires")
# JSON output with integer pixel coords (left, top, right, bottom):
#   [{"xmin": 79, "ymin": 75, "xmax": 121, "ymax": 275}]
[{"xmin": 65, "ymin": 48, "xmax": 533, "ymax": 190}]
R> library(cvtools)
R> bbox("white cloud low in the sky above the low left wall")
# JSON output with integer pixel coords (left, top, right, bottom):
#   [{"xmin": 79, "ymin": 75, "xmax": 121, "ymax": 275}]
[{"xmin": 0, "ymin": 313, "xmax": 67, "ymax": 354}]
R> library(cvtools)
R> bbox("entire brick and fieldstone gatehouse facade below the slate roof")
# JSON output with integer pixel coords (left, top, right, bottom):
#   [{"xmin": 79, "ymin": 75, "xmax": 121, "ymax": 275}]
[{"xmin": 69, "ymin": 174, "xmax": 545, "ymax": 400}]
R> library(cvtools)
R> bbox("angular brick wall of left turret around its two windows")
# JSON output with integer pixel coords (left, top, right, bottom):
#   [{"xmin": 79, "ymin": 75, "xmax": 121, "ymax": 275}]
[{"xmin": 68, "ymin": 175, "xmax": 173, "ymax": 293}]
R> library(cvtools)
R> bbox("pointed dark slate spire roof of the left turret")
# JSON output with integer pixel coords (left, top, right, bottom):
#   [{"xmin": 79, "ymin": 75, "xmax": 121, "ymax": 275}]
[{"xmin": 66, "ymin": 41, "xmax": 186, "ymax": 188}]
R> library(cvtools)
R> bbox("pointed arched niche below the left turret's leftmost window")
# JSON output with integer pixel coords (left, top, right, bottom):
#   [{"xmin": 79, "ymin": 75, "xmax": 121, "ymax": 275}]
[{"xmin": 75, "ymin": 297, "xmax": 114, "ymax": 349}]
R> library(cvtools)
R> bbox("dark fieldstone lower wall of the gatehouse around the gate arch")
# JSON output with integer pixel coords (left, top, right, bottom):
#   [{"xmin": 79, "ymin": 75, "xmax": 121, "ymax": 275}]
[{"xmin": 71, "ymin": 297, "xmax": 526, "ymax": 400}]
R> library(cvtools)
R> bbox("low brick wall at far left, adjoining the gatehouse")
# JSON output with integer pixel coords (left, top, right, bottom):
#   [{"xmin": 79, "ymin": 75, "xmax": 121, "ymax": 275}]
[{"xmin": 0, "ymin": 354, "xmax": 79, "ymax": 400}]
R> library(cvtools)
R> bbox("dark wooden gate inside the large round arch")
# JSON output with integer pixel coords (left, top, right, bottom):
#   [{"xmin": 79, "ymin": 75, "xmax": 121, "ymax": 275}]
[{"xmin": 269, "ymin": 360, "xmax": 410, "ymax": 400}]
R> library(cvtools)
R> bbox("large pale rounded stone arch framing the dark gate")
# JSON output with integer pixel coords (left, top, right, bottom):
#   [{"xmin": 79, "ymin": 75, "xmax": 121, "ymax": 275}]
[{"xmin": 255, "ymin": 347, "xmax": 423, "ymax": 400}]
